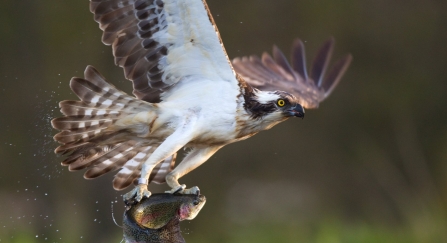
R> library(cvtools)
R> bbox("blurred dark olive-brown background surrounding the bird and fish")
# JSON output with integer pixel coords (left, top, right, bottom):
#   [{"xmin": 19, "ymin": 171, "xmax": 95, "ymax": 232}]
[{"xmin": 0, "ymin": 0, "xmax": 447, "ymax": 243}]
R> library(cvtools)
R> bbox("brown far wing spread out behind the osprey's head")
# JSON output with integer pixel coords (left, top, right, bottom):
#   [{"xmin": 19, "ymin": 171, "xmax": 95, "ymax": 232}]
[{"xmin": 233, "ymin": 38, "xmax": 352, "ymax": 108}]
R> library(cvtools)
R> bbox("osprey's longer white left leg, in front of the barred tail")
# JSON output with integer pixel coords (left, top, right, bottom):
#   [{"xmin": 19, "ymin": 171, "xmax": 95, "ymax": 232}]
[{"xmin": 124, "ymin": 115, "xmax": 196, "ymax": 202}]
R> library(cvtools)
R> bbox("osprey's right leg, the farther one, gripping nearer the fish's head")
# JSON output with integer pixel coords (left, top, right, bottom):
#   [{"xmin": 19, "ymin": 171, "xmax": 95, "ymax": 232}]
[{"xmin": 166, "ymin": 146, "xmax": 222, "ymax": 194}]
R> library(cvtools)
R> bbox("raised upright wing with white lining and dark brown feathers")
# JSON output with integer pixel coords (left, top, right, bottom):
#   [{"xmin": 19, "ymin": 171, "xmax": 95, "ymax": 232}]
[{"xmin": 90, "ymin": 0, "xmax": 238, "ymax": 103}]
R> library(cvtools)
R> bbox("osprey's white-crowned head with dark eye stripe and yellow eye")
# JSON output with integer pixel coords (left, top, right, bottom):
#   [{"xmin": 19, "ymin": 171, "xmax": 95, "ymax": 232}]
[{"xmin": 245, "ymin": 90, "xmax": 304, "ymax": 122}]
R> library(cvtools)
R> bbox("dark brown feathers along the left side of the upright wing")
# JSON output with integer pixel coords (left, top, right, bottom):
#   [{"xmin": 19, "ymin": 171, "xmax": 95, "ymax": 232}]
[{"xmin": 90, "ymin": 0, "xmax": 174, "ymax": 102}]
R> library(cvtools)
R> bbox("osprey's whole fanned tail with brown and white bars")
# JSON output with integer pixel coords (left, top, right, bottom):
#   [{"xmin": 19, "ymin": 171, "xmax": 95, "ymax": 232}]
[{"xmin": 52, "ymin": 66, "xmax": 175, "ymax": 190}]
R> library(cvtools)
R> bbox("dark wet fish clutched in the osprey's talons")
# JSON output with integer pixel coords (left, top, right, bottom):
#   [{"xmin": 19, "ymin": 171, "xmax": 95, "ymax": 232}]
[{"xmin": 122, "ymin": 193, "xmax": 206, "ymax": 243}]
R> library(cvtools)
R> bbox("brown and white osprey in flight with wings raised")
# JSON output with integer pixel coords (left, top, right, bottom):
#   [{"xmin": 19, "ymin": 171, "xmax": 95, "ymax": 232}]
[{"xmin": 52, "ymin": 0, "xmax": 351, "ymax": 201}]
